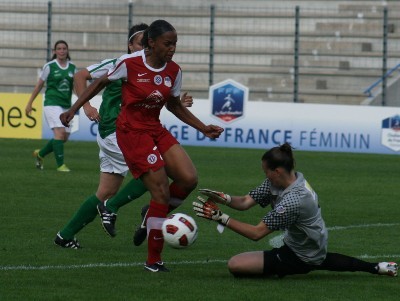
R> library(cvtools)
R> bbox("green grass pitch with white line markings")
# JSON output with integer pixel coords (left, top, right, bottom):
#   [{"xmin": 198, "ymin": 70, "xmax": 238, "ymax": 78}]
[{"xmin": 0, "ymin": 139, "xmax": 400, "ymax": 301}]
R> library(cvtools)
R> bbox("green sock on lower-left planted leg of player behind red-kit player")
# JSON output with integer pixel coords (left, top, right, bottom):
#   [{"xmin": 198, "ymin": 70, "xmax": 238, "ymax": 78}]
[{"xmin": 60, "ymin": 195, "xmax": 101, "ymax": 239}]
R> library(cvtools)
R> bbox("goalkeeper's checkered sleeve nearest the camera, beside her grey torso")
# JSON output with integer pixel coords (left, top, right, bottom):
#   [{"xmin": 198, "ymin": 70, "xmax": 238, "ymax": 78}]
[{"xmin": 263, "ymin": 192, "xmax": 300, "ymax": 231}]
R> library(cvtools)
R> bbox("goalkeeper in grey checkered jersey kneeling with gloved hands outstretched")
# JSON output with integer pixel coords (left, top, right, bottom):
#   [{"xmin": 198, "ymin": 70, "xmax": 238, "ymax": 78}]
[{"xmin": 193, "ymin": 143, "xmax": 398, "ymax": 277}]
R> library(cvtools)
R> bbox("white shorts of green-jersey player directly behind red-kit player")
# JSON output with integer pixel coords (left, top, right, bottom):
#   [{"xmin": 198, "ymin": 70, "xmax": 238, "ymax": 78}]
[{"xmin": 97, "ymin": 132, "xmax": 129, "ymax": 177}]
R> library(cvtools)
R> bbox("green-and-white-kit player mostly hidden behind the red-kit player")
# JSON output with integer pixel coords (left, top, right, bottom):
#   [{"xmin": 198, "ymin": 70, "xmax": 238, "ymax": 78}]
[{"xmin": 54, "ymin": 24, "xmax": 148, "ymax": 249}]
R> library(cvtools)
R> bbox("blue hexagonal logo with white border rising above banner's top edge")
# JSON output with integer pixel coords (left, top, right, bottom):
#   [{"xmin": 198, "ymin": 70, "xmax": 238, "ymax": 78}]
[{"xmin": 210, "ymin": 80, "xmax": 248, "ymax": 122}]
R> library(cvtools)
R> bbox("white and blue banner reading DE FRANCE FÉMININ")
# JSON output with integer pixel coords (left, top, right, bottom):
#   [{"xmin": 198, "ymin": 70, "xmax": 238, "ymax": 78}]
[{"xmin": 161, "ymin": 99, "xmax": 400, "ymax": 154}]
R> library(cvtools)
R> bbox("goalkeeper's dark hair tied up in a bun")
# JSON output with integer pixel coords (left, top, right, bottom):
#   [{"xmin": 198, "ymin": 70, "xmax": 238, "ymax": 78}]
[{"xmin": 261, "ymin": 142, "xmax": 295, "ymax": 172}]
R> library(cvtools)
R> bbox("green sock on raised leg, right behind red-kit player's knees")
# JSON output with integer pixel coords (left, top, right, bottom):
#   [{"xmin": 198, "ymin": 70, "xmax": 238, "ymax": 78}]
[{"xmin": 106, "ymin": 179, "xmax": 147, "ymax": 213}]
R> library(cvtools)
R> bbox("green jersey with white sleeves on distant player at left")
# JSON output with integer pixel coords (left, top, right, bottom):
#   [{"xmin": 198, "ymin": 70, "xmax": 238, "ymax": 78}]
[{"xmin": 40, "ymin": 59, "xmax": 76, "ymax": 108}]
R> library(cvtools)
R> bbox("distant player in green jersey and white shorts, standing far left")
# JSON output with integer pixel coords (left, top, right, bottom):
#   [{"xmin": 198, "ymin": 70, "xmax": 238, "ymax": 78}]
[{"xmin": 25, "ymin": 40, "xmax": 76, "ymax": 172}]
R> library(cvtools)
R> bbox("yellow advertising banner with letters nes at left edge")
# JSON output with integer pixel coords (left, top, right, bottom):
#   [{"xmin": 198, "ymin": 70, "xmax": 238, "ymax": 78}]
[{"xmin": 0, "ymin": 93, "xmax": 43, "ymax": 139}]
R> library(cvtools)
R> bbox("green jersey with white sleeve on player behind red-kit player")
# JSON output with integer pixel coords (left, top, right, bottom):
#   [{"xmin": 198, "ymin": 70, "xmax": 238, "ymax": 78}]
[{"xmin": 86, "ymin": 59, "xmax": 122, "ymax": 139}]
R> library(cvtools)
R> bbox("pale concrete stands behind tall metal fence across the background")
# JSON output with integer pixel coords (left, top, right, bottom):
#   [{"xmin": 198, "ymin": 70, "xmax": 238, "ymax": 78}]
[{"xmin": 0, "ymin": 1, "xmax": 400, "ymax": 106}]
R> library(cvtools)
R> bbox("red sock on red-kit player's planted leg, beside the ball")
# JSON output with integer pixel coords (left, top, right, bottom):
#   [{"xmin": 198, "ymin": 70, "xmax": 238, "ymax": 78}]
[{"xmin": 146, "ymin": 200, "xmax": 168, "ymax": 265}]
